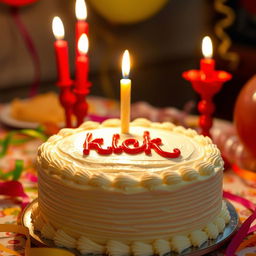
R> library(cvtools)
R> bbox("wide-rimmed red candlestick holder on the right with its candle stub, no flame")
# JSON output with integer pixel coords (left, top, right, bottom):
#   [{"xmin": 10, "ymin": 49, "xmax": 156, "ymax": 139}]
[{"xmin": 182, "ymin": 67, "xmax": 232, "ymax": 137}]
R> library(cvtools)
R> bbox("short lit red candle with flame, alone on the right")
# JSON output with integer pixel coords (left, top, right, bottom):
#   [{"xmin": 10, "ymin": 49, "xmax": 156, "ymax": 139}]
[{"xmin": 200, "ymin": 36, "xmax": 215, "ymax": 77}]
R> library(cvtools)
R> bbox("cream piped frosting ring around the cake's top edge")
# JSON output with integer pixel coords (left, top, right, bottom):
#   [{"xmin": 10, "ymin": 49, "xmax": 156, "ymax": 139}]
[{"xmin": 37, "ymin": 118, "xmax": 224, "ymax": 192}]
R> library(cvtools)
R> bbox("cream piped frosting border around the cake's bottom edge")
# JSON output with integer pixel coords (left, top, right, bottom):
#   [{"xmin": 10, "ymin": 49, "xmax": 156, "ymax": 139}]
[{"xmin": 32, "ymin": 201, "xmax": 230, "ymax": 256}]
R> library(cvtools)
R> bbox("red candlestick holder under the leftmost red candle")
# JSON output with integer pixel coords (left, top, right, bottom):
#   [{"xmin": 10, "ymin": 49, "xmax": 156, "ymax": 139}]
[{"xmin": 57, "ymin": 80, "xmax": 76, "ymax": 128}]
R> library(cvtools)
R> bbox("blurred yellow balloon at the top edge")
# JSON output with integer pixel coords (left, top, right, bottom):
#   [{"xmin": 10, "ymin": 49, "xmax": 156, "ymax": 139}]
[{"xmin": 90, "ymin": 0, "xmax": 168, "ymax": 24}]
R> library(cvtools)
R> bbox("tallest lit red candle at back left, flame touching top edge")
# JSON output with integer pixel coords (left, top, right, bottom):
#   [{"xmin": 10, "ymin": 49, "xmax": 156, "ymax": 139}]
[{"xmin": 75, "ymin": 0, "xmax": 89, "ymax": 56}]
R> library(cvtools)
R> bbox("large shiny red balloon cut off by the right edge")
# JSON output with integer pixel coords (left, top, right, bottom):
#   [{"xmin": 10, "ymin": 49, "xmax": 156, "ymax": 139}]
[{"xmin": 234, "ymin": 75, "xmax": 256, "ymax": 157}]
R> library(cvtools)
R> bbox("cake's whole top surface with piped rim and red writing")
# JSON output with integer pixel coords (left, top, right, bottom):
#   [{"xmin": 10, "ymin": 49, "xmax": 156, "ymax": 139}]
[{"xmin": 38, "ymin": 119, "xmax": 223, "ymax": 191}]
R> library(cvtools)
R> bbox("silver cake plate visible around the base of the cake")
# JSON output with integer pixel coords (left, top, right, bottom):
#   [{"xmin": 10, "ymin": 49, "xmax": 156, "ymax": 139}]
[{"xmin": 20, "ymin": 199, "xmax": 239, "ymax": 256}]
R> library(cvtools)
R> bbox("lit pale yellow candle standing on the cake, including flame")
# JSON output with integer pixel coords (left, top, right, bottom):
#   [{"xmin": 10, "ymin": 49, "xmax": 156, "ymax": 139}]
[{"xmin": 120, "ymin": 50, "xmax": 131, "ymax": 133}]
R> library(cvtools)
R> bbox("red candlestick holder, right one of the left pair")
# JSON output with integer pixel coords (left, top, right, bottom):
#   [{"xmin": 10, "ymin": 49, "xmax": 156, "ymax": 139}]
[{"xmin": 74, "ymin": 82, "xmax": 91, "ymax": 127}]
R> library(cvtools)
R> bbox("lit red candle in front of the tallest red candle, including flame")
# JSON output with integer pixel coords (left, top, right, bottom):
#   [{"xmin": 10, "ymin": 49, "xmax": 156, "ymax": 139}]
[{"xmin": 75, "ymin": 34, "xmax": 89, "ymax": 91}]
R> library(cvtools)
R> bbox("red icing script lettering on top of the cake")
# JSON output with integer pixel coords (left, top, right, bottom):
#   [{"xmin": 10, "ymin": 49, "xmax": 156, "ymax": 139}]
[{"xmin": 83, "ymin": 131, "xmax": 180, "ymax": 158}]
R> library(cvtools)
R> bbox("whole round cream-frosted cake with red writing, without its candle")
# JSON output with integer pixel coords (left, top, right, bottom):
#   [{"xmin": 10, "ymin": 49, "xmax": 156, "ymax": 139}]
[{"xmin": 32, "ymin": 119, "xmax": 230, "ymax": 256}]
